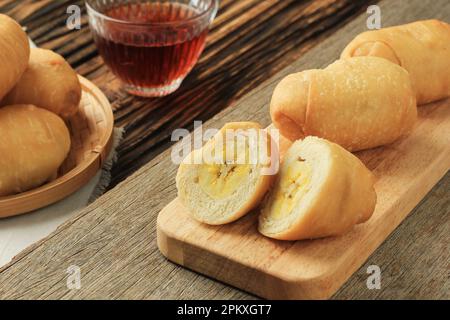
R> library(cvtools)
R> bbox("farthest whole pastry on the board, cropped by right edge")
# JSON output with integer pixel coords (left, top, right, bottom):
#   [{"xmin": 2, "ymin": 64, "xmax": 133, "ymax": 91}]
[{"xmin": 341, "ymin": 20, "xmax": 450, "ymax": 104}]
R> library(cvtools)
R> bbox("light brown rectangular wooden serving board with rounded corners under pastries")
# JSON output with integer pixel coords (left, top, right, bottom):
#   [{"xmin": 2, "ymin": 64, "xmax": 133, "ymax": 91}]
[{"xmin": 157, "ymin": 96, "xmax": 450, "ymax": 299}]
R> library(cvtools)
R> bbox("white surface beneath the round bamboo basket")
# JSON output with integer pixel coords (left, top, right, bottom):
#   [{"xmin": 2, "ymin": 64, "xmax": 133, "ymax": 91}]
[{"xmin": 0, "ymin": 171, "xmax": 101, "ymax": 267}]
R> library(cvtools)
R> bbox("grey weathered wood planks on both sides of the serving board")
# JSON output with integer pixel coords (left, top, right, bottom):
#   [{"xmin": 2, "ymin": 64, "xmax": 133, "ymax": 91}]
[{"xmin": 0, "ymin": 0, "xmax": 450, "ymax": 299}]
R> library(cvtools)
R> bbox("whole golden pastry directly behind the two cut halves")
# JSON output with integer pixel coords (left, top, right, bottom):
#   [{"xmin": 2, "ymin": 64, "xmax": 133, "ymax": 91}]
[{"xmin": 271, "ymin": 57, "xmax": 417, "ymax": 151}]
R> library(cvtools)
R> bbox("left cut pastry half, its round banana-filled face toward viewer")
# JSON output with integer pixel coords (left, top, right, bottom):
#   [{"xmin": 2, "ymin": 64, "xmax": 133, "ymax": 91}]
[{"xmin": 176, "ymin": 122, "xmax": 278, "ymax": 225}]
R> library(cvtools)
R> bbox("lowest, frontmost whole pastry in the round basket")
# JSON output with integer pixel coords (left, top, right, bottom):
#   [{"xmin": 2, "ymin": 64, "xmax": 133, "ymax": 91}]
[{"xmin": 0, "ymin": 105, "xmax": 70, "ymax": 196}]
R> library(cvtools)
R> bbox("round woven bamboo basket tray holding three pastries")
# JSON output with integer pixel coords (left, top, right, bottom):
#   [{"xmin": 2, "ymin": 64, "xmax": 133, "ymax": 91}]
[{"xmin": 0, "ymin": 76, "xmax": 114, "ymax": 218}]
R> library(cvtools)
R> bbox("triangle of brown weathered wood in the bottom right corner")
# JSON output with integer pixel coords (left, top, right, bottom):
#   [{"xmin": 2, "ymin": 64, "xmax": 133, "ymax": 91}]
[{"xmin": 336, "ymin": 173, "xmax": 450, "ymax": 300}]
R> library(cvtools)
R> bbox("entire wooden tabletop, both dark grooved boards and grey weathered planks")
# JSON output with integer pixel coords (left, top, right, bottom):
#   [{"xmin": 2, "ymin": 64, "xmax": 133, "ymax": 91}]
[{"xmin": 0, "ymin": 0, "xmax": 450, "ymax": 299}]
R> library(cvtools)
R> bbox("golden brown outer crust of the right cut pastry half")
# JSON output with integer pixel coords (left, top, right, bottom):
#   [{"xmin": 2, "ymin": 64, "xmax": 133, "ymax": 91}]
[{"xmin": 259, "ymin": 137, "xmax": 377, "ymax": 240}]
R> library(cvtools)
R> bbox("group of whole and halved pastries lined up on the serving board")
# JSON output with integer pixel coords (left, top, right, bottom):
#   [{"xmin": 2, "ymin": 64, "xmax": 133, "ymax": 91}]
[{"xmin": 176, "ymin": 20, "xmax": 450, "ymax": 240}]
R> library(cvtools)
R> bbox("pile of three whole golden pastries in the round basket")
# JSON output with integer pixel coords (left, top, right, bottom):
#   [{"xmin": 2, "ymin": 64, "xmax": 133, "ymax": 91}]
[{"xmin": 0, "ymin": 14, "xmax": 81, "ymax": 197}]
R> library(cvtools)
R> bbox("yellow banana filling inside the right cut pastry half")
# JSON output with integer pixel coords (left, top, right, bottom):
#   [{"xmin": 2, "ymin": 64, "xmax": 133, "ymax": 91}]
[{"xmin": 270, "ymin": 158, "xmax": 311, "ymax": 220}]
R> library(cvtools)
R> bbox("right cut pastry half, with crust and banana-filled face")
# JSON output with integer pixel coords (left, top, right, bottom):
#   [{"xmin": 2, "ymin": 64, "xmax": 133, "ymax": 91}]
[{"xmin": 259, "ymin": 137, "xmax": 377, "ymax": 240}]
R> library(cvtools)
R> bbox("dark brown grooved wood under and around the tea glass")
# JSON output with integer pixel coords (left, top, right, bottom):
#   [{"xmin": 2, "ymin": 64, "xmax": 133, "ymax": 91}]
[{"xmin": 0, "ymin": 0, "xmax": 374, "ymax": 187}]
